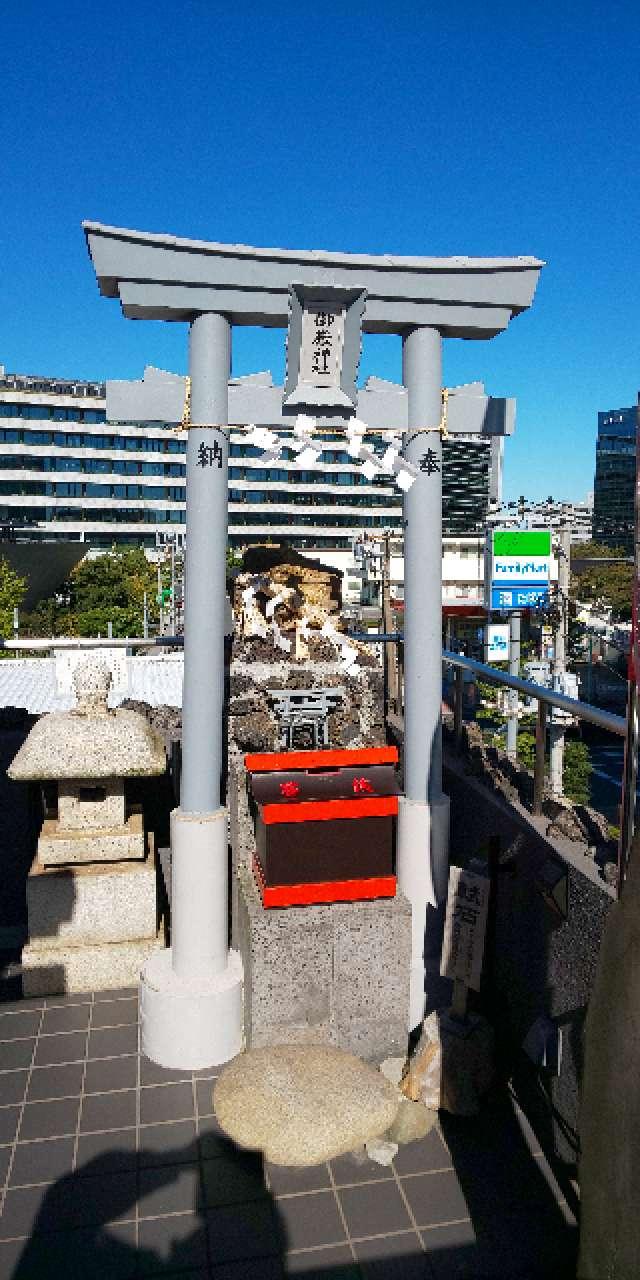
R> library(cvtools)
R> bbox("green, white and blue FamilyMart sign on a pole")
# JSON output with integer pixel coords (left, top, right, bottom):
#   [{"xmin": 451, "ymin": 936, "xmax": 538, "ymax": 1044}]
[{"xmin": 489, "ymin": 529, "xmax": 552, "ymax": 609}]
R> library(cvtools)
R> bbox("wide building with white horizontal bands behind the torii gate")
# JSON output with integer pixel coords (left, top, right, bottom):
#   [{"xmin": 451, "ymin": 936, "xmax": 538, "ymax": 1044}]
[{"xmin": 0, "ymin": 366, "xmax": 502, "ymax": 559}]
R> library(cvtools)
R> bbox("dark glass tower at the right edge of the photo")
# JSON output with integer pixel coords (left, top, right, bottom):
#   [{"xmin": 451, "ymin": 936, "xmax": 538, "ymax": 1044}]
[{"xmin": 594, "ymin": 406, "xmax": 637, "ymax": 553}]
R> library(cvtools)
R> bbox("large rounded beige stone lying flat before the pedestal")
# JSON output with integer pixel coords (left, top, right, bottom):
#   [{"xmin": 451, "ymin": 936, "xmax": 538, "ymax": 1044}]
[{"xmin": 214, "ymin": 1044, "xmax": 398, "ymax": 1166}]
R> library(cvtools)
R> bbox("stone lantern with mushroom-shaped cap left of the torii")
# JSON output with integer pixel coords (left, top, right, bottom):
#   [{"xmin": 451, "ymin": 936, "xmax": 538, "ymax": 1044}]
[{"xmin": 8, "ymin": 659, "xmax": 166, "ymax": 996}]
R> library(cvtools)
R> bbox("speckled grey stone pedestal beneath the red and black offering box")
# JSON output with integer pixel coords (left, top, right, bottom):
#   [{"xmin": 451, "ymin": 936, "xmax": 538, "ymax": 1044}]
[{"xmin": 237, "ymin": 868, "xmax": 411, "ymax": 1064}]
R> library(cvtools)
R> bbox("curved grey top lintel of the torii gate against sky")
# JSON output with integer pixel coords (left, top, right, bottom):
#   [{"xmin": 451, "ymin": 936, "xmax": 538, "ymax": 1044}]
[{"xmin": 83, "ymin": 221, "xmax": 544, "ymax": 338}]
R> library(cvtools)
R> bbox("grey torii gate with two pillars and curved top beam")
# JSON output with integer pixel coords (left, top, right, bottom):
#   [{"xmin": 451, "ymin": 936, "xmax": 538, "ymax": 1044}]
[{"xmin": 83, "ymin": 223, "xmax": 543, "ymax": 1069}]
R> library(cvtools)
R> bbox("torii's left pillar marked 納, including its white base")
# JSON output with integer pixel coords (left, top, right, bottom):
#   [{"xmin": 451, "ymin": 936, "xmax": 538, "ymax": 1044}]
[{"xmin": 141, "ymin": 311, "xmax": 242, "ymax": 1070}]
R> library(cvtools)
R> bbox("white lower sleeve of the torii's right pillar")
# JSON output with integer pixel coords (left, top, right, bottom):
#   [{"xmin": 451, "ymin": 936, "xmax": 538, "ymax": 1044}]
[{"xmin": 398, "ymin": 795, "xmax": 449, "ymax": 1030}]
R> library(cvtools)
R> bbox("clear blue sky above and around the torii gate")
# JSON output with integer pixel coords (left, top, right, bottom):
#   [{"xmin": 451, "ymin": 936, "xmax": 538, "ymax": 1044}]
[{"xmin": 0, "ymin": 0, "xmax": 640, "ymax": 498}]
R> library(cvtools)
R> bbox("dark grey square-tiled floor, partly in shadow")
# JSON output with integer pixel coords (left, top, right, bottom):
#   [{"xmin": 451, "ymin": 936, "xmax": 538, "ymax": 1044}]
[{"xmin": 0, "ymin": 991, "xmax": 575, "ymax": 1280}]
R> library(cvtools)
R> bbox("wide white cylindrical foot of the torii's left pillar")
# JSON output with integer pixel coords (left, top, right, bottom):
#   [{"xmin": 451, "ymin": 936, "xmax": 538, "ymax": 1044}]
[{"xmin": 140, "ymin": 948, "xmax": 243, "ymax": 1071}]
